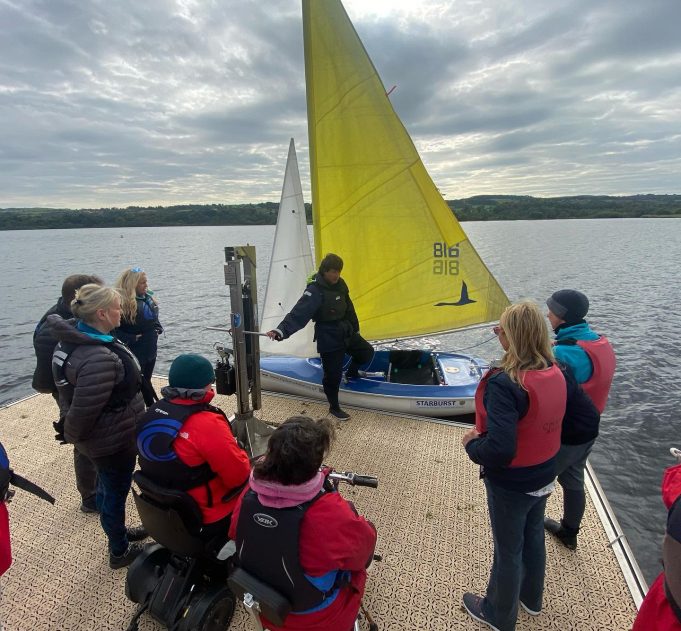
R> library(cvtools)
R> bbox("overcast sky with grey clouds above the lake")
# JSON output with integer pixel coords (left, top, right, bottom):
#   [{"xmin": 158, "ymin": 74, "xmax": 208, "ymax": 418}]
[{"xmin": 0, "ymin": 0, "xmax": 681, "ymax": 208}]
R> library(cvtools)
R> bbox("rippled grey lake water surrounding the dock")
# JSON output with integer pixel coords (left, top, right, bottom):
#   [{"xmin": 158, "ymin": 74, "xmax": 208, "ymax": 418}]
[{"xmin": 0, "ymin": 219, "xmax": 681, "ymax": 582}]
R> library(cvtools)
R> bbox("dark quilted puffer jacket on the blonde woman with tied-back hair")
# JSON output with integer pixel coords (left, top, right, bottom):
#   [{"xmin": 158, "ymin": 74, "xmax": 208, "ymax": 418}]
[{"xmin": 47, "ymin": 315, "xmax": 144, "ymax": 458}]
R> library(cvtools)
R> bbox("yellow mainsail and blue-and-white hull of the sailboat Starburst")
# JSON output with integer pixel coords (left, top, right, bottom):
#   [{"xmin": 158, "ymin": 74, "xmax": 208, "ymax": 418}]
[{"xmin": 261, "ymin": 0, "xmax": 509, "ymax": 417}]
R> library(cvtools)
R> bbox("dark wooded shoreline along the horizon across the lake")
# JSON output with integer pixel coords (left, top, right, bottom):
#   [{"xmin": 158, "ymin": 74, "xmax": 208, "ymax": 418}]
[{"xmin": 0, "ymin": 195, "xmax": 681, "ymax": 230}]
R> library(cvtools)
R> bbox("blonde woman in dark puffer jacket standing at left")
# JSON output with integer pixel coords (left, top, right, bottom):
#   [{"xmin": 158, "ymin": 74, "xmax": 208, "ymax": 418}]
[{"xmin": 47, "ymin": 284, "xmax": 146, "ymax": 569}]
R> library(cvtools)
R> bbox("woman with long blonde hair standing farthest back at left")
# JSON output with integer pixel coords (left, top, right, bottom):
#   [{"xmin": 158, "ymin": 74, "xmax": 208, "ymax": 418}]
[{"xmin": 115, "ymin": 267, "xmax": 163, "ymax": 406}]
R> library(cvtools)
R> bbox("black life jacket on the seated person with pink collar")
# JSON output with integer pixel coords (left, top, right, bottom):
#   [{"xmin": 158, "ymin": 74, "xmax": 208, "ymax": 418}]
[{"xmin": 235, "ymin": 490, "xmax": 342, "ymax": 611}]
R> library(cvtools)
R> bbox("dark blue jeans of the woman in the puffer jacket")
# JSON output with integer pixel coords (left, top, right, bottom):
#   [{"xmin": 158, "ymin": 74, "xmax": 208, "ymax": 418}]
[{"xmin": 94, "ymin": 455, "xmax": 136, "ymax": 556}]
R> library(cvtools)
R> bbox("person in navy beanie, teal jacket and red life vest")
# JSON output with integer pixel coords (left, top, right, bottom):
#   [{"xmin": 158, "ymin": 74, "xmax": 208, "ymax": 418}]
[{"xmin": 544, "ymin": 289, "xmax": 615, "ymax": 550}]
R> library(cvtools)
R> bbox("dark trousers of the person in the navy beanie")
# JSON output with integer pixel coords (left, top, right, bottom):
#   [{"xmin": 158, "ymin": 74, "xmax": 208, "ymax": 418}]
[{"xmin": 556, "ymin": 438, "xmax": 596, "ymax": 534}]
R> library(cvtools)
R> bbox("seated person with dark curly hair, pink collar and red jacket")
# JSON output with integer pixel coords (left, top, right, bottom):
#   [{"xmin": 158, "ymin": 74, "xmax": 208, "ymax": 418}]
[{"xmin": 229, "ymin": 416, "xmax": 376, "ymax": 631}]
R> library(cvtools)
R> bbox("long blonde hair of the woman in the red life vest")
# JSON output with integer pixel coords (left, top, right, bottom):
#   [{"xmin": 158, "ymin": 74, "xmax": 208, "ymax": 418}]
[{"xmin": 499, "ymin": 301, "xmax": 554, "ymax": 388}]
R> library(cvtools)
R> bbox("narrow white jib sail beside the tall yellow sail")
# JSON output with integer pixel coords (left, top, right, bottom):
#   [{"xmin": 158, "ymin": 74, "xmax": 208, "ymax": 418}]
[{"xmin": 260, "ymin": 138, "xmax": 317, "ymax": 357}]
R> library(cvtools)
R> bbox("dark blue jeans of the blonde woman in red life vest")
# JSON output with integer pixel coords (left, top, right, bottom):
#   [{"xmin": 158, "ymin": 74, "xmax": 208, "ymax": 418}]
[{"xmin": 482, "ymin": 478, "xmax": 548, "ymax": 631}]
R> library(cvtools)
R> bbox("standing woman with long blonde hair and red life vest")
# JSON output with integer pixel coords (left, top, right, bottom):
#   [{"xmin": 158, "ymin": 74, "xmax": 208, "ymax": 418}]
[{"xmin": 462, "ymin": 302, "xmax": 568, "ymax": 631}]
